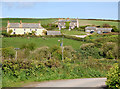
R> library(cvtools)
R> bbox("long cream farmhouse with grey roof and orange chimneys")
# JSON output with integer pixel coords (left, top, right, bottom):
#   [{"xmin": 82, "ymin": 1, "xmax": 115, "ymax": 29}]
[{"xmin": 7, "ymin": 21, "xmax": 46, "ymax": 35}]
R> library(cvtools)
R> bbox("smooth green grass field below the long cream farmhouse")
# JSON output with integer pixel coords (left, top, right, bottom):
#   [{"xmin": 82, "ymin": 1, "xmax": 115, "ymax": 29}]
[{"xmin": 2, "ymin": 37, "xmax": 83, "ymax": 49}]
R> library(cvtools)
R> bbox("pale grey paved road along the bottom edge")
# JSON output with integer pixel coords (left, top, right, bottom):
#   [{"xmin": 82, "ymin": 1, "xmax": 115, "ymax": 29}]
[{"xmin": 24, "ymin": 78, "xmax": 106, "ymax": 87}]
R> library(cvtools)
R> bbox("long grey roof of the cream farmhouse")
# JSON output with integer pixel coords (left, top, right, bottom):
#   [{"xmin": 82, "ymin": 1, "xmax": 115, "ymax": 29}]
[{"xmin": 9, "ymin": 23, "xmax": 42, "ymax": 28}]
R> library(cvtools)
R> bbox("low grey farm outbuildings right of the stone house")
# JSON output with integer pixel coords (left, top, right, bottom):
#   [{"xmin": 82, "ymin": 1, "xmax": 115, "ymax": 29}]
[{"xmin": 85, "ymin": 27, "xmax": 112, "ymax": 33}]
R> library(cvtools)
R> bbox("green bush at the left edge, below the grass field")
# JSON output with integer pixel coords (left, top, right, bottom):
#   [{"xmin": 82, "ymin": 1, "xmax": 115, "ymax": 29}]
[{"xmin": 2, "ymin": 47, "xmax": 15, "ymax": 59}]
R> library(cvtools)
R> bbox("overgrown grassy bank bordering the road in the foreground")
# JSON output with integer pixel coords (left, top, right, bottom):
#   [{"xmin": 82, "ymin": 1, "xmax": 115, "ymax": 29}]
[{"xmin": 3, "ymin": 59, "xmax": 116, "ymax": 87}]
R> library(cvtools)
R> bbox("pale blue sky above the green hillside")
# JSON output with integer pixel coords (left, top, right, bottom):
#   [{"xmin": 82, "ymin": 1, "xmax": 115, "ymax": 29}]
[{"xmin": 2, "ymin": 2, "xmax": 118, "ymax": 20}]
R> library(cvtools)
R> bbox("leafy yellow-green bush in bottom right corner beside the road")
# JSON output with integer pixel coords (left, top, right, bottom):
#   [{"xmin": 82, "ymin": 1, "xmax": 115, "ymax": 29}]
[{"xmin": 106, "ymin": 63, "xmax": 120, "ymax": 89}]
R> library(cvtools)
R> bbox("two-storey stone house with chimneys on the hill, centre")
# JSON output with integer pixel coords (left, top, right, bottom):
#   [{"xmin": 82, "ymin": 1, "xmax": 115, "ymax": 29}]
[{"xmin": 58, "ymin": 19, "xmax": 79, "ymax": 30}]
